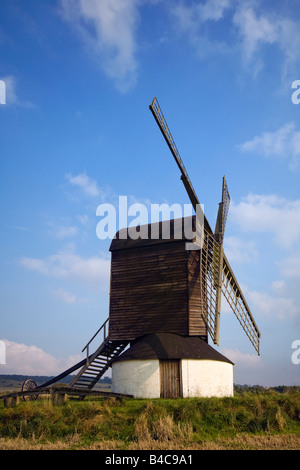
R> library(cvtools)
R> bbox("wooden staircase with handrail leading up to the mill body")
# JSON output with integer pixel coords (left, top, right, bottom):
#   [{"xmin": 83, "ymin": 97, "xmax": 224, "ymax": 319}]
[{"xmin": 71, "ymin": 320, "xmax": 128, "ymax": 390}]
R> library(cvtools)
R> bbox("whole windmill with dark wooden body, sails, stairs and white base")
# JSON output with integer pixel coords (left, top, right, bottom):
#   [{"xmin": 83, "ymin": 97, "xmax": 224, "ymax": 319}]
[{"xmin": 13, "ymin": 98, "xmax": 260, "ymax": 398}]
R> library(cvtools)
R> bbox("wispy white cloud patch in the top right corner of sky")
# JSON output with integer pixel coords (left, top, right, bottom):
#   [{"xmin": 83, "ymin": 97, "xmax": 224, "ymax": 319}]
[{"xmin": 171, "ymin": 0, "xmax": 300, "ymax": 79}]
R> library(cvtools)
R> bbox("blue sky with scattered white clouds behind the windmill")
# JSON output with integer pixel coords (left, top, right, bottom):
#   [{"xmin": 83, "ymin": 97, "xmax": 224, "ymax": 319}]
[{"xmin": 0, "ymin": 0, "xmax": 300, "ymax": 386}]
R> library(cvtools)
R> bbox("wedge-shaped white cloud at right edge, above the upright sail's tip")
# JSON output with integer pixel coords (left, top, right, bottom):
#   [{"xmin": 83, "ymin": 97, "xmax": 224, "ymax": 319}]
[{"xmin": 238, "ymin": 122, "xmax": 300, "ymax": 169}]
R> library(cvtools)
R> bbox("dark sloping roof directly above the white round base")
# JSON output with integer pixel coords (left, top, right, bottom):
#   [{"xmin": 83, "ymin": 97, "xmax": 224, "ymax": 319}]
[{"xmin": 114, "ymin": 333, "xmax": 233, "ymax": 364}]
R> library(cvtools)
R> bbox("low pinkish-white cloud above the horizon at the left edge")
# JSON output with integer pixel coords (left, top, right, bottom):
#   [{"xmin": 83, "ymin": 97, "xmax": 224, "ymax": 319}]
[{"xmin": 0, "ymin": 339, "xmax": 83, "ymax": 376}]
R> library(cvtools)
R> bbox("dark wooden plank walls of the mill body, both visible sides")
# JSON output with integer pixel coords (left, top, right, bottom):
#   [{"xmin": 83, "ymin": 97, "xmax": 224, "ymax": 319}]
[{"xmin": 109, "ymin": 219, "xmax": 207, "ymax": 341}]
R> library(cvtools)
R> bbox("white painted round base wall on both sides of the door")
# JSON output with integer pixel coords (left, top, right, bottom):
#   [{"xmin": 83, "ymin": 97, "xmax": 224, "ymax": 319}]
[{"xmin": 112, "ymin": 359, "xmax": 233, "ymax": 398}]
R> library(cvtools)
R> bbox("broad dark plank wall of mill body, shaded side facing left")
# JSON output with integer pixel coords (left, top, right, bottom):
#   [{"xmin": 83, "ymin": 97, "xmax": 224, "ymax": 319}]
[{"xmin": 109, "ymin": 243, "xmax": 188, "ymax": 340}]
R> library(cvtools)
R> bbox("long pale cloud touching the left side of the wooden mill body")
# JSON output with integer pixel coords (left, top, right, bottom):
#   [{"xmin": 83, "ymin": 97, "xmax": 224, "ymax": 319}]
[{"xmin": 20, "ymin": 252, "xmax": 110, "ymax": 290}]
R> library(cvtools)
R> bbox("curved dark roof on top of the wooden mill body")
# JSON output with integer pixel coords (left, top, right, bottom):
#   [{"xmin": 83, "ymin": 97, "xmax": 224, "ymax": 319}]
[{"xmin": 109, "ymin": 216, "xmax": 196, "ymax": 251}]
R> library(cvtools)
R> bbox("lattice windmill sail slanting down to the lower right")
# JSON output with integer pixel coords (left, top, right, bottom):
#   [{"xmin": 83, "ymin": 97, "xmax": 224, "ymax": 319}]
[{"xmin": 222, "ymin": 253, "xmax": 261, "ymax": 354}]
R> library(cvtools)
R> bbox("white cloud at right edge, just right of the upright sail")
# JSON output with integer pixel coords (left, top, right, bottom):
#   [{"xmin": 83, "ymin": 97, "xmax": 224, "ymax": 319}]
[{"xmin": 230, "ymin": 194, "xmax": 300, "ymax": 249}]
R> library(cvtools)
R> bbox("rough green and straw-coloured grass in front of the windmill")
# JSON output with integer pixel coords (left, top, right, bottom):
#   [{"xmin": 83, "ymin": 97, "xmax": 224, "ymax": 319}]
[{"xmin": 0, "ymin": 390, "xmax": 300, "ymax": 450}]
